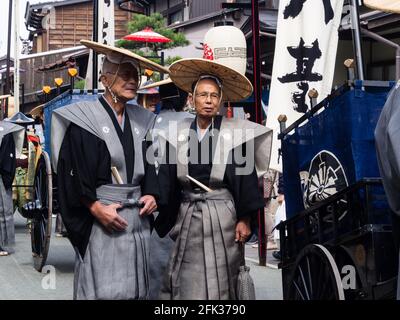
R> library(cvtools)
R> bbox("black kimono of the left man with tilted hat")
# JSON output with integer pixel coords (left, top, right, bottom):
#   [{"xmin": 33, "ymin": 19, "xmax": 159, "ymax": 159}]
[{"xmin": 57, "ymin": 97, "xmax": 159, "ymax": 257}]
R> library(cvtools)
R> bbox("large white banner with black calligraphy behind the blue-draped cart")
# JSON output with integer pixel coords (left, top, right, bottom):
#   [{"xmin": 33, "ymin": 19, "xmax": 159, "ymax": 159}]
[{"xmin": 266, "ymin": 0, "xmax": 343, "ymax": 171}]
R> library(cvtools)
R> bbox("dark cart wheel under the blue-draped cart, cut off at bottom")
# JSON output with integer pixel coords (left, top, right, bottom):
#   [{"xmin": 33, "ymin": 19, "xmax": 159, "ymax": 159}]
[{"xmin": 285, "ymin": 244, "xmax": 344, "ymax": 300}]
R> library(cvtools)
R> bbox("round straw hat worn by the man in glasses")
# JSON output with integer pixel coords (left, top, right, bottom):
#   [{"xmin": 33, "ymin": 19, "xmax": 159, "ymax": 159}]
[{"xmin": 169, "ymin": 58, "xmax": 253, "ymax": 102}]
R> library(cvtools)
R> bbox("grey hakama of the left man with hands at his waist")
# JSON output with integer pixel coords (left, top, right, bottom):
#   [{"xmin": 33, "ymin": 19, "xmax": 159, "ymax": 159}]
[{"xmin": 74, "ymin": 185, "xmax": 150, "ymax": 300}]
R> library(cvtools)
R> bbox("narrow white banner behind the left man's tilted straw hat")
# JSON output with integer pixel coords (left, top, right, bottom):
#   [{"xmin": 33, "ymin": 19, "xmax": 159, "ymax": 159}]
[{"xmin": 85, "ymin": 0, "xmax": 115, "ymax": 89}]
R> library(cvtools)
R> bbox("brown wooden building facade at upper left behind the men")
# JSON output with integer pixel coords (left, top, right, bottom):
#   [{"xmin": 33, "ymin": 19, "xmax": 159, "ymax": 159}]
[{"xmin": 15, "ymin": 0, "xmax": 143, "ymax": 112}]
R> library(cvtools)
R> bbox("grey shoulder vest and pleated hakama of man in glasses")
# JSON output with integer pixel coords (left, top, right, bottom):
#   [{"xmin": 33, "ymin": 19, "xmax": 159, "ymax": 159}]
[{"xmin": 160, "ymin": 119, "xmax": 272, "ymax": 300}]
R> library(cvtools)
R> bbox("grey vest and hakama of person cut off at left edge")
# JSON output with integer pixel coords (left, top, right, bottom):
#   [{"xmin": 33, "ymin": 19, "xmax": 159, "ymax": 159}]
[{"xmin": 0, "ymin": 121, "xmax": 25, "ymax": 253}]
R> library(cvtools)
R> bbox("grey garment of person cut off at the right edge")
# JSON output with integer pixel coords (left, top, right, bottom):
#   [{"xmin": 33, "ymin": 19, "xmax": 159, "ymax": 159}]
[{"xmin": 375, "ymin": 81, "xmax": 400, "ymax": 300}]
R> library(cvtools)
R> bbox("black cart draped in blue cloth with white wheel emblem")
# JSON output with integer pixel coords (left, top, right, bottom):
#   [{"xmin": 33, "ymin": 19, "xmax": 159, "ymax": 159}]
[{"xmin": 277, "ymin": 80, "xmax": 398, "ymax": 300}]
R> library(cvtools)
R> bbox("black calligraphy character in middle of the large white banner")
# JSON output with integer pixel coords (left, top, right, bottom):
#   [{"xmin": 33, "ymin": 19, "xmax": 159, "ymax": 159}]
[{"xmin": 278, "ymin": 38, "xmax": 323, "ymax": 113}]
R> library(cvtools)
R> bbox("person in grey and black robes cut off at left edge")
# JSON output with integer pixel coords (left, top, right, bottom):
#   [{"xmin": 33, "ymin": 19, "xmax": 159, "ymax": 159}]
[{"xmin": 0, "ymin": 121, "xmax": 25, "ymax": 257}]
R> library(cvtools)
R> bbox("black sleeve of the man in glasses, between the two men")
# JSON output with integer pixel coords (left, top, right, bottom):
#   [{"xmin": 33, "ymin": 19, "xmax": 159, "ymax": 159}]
[{"xmin": 154, "ymin": 143, "xmax": 182, "ymax": 237}]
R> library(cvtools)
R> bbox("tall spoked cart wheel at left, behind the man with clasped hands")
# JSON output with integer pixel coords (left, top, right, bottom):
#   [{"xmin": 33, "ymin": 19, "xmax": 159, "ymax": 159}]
[{"xmin": 31, "ymin": 151, "xmax": 53, "ymax": 272}]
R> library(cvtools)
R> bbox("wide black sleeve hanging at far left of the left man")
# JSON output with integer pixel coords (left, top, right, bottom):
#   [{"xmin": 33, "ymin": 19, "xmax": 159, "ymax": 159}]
[{"xmin": 57, "ymin": 124, "xmax": 111, "ymax": 257}]
